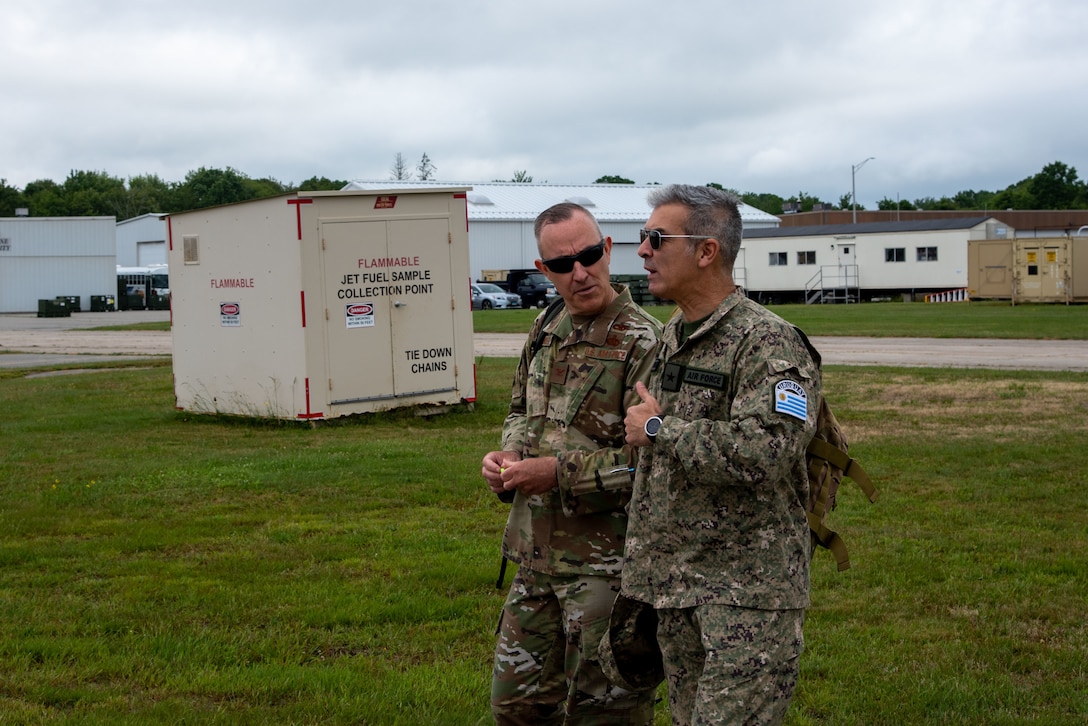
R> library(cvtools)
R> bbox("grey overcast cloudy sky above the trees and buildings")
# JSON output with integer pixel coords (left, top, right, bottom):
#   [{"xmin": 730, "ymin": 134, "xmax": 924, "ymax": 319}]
[{"xmin": 0, "ymin": 0, "xmax": 1088, "ymax": 209}]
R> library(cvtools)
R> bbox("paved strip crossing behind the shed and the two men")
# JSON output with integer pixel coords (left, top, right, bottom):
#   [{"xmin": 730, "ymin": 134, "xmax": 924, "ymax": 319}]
[{"xmin": 0, "ymin": 310, "xmax": 1088, "ymax": 371}]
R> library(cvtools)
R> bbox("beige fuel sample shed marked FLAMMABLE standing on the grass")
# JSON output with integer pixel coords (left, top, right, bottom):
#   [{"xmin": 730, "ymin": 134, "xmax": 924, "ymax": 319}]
[{"xmin": 166, "ymin": 187, "xmax": 475, "ymax": 420}]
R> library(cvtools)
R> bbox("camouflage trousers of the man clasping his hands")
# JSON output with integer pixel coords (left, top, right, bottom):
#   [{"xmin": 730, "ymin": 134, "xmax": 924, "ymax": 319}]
[{"xmin": 491, "ymin": 567, "xmax": 654, "ymax": 726}]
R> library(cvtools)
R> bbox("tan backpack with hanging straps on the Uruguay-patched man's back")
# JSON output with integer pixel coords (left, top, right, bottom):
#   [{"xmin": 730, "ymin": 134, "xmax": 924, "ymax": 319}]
[{"xmin": 794, "ymin": 328, "xmax": 877, "ymax": 571}]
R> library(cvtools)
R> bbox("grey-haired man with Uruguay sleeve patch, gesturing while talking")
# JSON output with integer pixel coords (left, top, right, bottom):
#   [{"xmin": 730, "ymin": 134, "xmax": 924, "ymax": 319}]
[{"xmin": 622, "ymin": 185, "xmax": 820, "ymax": 724}]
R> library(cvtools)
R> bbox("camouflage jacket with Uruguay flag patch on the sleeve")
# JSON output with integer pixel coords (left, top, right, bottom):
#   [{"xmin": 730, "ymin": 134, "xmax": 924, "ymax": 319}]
[{"xmin": 622, "ymin": 293, "xmax": 820, "ymax": 610}]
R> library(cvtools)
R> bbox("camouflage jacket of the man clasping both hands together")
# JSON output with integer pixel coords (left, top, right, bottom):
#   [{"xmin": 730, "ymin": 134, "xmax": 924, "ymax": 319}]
[{"xmin": 503, "ymin": 285, "xmax": 662, "ymax": 577}]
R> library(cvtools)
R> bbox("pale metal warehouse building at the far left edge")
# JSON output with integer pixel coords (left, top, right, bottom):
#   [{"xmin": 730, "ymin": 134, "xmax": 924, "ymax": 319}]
[{"xmin": 0, "ymin": 217, "xmax": 118, "ymax": 312}]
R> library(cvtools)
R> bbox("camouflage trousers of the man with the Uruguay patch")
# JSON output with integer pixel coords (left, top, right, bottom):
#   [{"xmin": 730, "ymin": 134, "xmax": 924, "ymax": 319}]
[{"xmin": 657, "ymin": 604, "xmax": 805, "ymax": 726}]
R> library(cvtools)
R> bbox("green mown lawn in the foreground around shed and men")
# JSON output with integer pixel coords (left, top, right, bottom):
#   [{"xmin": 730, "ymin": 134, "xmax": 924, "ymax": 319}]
[{"xmin": 0, "ymin": 304, "xmax": 1088, "ymax": 726}]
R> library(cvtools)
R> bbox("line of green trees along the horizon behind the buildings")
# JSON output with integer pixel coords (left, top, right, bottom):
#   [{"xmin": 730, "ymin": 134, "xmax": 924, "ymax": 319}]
[{"xmin": 0, "ymin": 160, "xmax": 1088, "ymax": 221}]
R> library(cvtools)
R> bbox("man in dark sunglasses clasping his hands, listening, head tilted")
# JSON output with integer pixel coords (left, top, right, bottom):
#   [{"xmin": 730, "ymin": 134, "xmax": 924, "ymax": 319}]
[{"xmin": 482, "ymin": 202, "xmax": 660, "ymax": 726}]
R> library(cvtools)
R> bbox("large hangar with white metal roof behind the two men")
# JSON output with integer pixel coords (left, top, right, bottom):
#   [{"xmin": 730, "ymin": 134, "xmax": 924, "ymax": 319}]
[{"xmin": 344, "ymin": 181, "xmax": 780, "ymax": 279}]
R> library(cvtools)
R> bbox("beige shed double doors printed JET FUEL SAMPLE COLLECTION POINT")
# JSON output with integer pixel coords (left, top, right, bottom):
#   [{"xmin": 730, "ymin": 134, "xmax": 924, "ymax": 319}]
[{"xmin": 321, "ymin": 218, "xmax": 456, "ymax": 405}]
